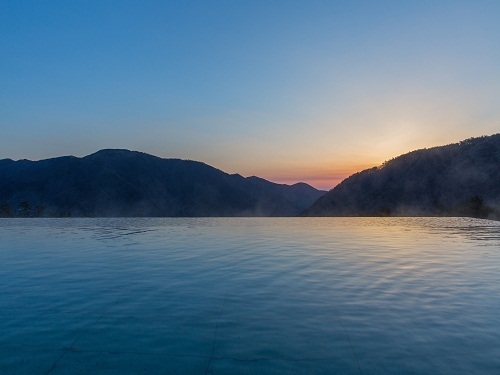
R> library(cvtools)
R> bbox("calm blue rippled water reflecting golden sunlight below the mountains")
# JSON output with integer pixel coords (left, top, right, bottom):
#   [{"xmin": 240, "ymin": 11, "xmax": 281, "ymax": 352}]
[{"xmin": 0, "ymin": 218, "xmax": 500, "ymax": 375}]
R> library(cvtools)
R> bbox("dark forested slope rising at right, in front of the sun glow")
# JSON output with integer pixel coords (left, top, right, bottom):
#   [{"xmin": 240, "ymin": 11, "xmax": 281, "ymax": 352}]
[{"xmin": 304, "ymin": 134, "xmax": 500, "ymax": 218}]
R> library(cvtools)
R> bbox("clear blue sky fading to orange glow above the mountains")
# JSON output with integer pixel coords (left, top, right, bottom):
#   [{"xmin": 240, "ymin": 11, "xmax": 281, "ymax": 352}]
[{"xmin": 0, "ymin": 0, "xmax": 500, "ymax": 190}]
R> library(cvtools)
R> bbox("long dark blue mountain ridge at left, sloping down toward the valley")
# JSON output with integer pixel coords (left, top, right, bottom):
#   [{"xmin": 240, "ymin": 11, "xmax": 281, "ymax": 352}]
[{"xmin": 0, "ymin": 150, "xmax": 325, "ymax": 217}]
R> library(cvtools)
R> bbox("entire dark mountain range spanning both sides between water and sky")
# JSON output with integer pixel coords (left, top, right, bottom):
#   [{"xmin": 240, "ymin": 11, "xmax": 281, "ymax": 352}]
[{"xmin": 0, "ymin": 134, "xmax": 500, "ymax": 219}]
